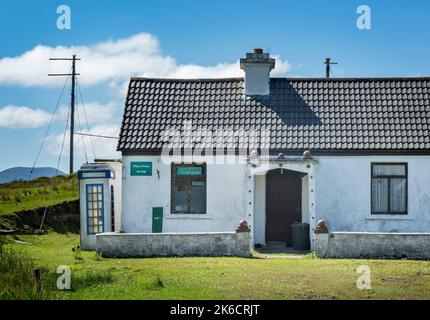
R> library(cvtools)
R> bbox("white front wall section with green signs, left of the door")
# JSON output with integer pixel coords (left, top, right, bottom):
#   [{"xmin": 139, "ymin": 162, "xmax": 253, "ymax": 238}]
[{"xmin": 122, "ymin": 156, "xmax": 249, "ymax": 232}]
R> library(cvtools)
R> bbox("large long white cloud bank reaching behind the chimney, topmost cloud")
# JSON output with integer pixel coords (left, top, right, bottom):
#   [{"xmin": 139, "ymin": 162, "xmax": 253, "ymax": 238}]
[{"xmin": 0, "ymin": 33, "xmax": 291, "ymax": 91}]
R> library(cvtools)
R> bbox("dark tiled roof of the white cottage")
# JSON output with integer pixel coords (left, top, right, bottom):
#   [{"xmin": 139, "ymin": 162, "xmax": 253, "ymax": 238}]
[{"xmin": 118, "ymin": 78, "xmax": 430, "ymax": 152}]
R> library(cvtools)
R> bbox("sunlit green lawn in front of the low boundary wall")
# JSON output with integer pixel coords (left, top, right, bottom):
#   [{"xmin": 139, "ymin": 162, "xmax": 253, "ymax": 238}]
[{"xmin": 0, "ymin": 233, "xmax": 430, "ymax": 299}]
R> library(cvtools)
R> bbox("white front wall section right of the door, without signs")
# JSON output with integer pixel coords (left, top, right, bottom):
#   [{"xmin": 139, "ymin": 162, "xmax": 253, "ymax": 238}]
[{"xmin": 315, "ymin": 156, "xmax": 430, "ymax": 232}]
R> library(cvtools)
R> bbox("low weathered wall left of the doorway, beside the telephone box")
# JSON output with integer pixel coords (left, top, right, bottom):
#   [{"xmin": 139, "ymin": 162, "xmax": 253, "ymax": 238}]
[{"xmin": 96, "ymin": 232, "xmax": 251, "ymax": 258}]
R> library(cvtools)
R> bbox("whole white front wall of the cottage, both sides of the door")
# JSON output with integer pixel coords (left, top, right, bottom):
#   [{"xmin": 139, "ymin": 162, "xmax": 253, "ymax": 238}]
[{"xmin": 122, "ymin": 155, "xmax": 430, "ymax": 247}]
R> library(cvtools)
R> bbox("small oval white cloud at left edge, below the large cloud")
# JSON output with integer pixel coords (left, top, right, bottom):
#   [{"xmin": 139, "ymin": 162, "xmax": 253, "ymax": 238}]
[{"xmin": 0, "ymin": 105, "xmax": 51, "ymax": 128}]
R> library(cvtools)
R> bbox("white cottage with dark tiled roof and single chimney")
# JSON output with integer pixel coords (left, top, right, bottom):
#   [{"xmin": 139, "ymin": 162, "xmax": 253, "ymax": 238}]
[{"xmin": 96, "ymin": 49, "xmax": 430, "ymax": 257}]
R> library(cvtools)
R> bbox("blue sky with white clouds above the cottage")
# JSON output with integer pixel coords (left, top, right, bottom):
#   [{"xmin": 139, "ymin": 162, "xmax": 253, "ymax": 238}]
[{"xmin": 0, "ymin": 0, "xmax": 430, "ymax": 171}]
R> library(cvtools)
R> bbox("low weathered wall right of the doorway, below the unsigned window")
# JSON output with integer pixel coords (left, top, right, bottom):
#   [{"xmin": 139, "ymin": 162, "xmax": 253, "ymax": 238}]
[{"xmin": 315, "ymin": 232, "xmax": 430, "ymax": 260}]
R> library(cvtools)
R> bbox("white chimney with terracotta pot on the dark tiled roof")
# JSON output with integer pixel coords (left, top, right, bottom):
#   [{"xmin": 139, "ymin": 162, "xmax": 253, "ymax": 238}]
[{"xmin": 240, "ymin": 49, "xmax": 275, "ymax": 96}]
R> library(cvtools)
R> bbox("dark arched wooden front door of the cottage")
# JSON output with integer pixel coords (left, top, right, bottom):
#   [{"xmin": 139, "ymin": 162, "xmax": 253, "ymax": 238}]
[{"xmin": 266, "ymin": 169, "xmax": 302, "ymax": 246}]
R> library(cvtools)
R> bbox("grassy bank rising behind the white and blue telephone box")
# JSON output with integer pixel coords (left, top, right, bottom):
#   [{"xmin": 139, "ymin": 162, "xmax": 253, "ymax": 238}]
[{"xmin": 0, "ymin": 174, "xmax": 79, "ymax": 216}]
